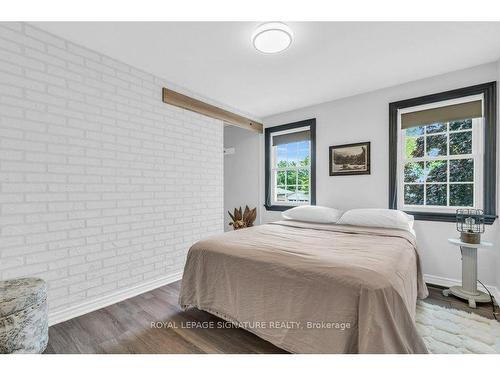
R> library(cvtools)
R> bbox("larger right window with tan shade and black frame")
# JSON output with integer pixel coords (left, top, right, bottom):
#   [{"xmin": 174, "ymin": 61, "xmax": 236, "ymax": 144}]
[{"xmin": 389, "ymin": 83, "xmax": 496, "ymax": 222}]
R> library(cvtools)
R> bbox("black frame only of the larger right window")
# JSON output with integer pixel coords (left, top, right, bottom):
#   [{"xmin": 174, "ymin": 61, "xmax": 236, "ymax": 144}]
[{"xmin": 389, "ymin": 81, "xmax": 497, "ymax": 225}]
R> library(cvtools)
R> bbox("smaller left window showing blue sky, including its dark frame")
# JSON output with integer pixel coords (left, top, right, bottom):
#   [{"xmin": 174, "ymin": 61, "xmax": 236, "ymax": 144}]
[{"xmin": 265, "ymin": 119, "xmax": 316, "ymax": 211}]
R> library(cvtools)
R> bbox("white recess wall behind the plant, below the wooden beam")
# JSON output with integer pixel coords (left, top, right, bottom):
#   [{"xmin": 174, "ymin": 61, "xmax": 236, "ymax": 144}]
[{"xmin": 224, "ymin": 126, "xmax": 261, "ymax": 231}]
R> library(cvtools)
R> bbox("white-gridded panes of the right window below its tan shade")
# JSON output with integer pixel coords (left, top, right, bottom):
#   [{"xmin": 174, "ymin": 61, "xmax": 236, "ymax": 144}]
[{"xmin": 398, "ymin": 104, "xmax": 483, "ymax": 212}]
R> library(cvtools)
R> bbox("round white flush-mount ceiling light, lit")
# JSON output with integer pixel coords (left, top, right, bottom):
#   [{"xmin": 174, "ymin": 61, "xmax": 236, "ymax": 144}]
[{"xmin": 252, "ymin": 22, "xmax": 293, "ymax": 53}]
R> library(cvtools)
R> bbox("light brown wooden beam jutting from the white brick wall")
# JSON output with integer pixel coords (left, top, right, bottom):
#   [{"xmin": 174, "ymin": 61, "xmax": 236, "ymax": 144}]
[{"xmin": 162, "ymin": 87, "xmax": 264, "ymax": 133}]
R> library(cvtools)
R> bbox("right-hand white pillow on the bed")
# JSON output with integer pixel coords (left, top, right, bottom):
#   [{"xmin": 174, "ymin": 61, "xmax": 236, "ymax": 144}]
[{"xmin": 337, "ymin": 208, "xmax": 413, "ymax": 233}]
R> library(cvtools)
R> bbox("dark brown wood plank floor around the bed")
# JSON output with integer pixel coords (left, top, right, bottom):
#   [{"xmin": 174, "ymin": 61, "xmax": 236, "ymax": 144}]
[{"xmin": 45, "ymin": 282, "xmax": 493, "ymax": 354}]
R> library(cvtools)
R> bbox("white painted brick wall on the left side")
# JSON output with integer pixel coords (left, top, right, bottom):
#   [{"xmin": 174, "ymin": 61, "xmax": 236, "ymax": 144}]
[{"xmin": 0, "ymin": 23, "xmax": 223, "ymax": 312}]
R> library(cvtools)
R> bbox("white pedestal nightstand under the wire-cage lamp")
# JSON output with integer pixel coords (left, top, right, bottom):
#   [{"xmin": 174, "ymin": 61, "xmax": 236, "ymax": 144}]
[{"xmin": 443, "ymin": 238, "xmax": 493, "ymax": 309}]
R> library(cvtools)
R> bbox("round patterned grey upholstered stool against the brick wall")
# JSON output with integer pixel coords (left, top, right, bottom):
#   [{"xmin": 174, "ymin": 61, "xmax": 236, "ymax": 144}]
[{"xmin": 0, "ymin": 278, "xmax": 49, "ymax": 353}]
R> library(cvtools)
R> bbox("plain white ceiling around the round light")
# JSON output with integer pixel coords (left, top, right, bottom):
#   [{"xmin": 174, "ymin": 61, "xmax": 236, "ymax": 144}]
[{"xmin": 34, "ymin": 22, "xmax": 500, "ymax": 118}]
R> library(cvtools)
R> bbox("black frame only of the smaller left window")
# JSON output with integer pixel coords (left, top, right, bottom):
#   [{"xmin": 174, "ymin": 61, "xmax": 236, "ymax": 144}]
[{"xmin": 264, "ymin": 118, "xmax": 316, "ymax": 211}]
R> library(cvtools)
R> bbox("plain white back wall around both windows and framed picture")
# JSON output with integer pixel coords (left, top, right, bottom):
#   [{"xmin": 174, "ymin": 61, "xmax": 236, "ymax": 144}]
[{"xmin": 261, "ymin": 62, "xmax": 500, "ymax": 287}]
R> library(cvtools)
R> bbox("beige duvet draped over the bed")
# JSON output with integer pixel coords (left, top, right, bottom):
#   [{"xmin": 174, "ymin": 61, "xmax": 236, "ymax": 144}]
[{"xmin": 179, "ymin": 221, "xmax": 427, "ymax": 353}]
